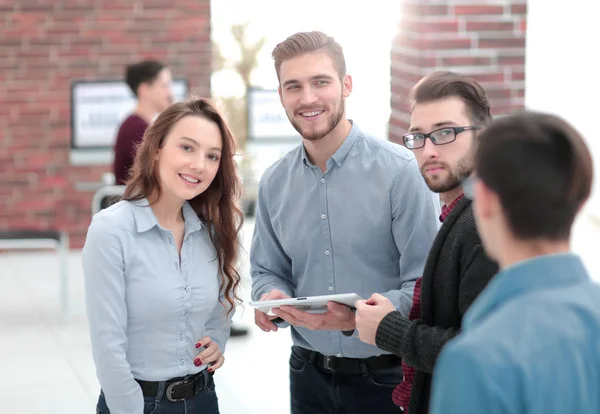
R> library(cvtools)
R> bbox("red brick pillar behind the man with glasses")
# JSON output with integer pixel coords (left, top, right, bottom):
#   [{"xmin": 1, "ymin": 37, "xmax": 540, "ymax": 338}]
[{"xmin": 389, "ymin": 0, "xmax": 527, "ymax": 143}]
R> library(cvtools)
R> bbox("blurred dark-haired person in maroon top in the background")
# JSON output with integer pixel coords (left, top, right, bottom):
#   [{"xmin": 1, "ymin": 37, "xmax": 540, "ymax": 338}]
[{"xmin": 113, "ymin": 60, "xmax": 173, "ymax": 185}]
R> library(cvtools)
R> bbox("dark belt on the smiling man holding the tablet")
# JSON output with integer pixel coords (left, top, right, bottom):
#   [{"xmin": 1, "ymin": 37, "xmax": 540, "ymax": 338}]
[{"xmin": 300, "ymin": 349, "xmax": 402, "ymax": 375}]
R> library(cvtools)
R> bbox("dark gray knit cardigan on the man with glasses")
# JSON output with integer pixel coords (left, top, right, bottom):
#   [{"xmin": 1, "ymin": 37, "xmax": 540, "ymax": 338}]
[{"xmin": 375, "ymin": 198, "xmax": 498, "ymax": 414}]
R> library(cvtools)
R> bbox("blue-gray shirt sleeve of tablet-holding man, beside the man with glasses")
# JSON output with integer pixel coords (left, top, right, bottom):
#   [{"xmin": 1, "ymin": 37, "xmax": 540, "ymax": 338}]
[{"xmin": 383, "ymin": 159, "xmax": 438, "ymax": 317}]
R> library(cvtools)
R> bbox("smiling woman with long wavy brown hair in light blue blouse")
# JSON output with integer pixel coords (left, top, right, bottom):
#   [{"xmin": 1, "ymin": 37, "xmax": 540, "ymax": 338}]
[{"xmin": 82, "ymin": 99, "xmax": 242, "ymax": 414}]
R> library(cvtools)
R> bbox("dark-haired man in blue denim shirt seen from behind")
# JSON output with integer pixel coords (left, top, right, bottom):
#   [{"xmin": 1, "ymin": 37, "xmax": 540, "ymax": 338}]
[{"xmin": 431, "ymin": 112, "xmax": 600, "ymax": 414}]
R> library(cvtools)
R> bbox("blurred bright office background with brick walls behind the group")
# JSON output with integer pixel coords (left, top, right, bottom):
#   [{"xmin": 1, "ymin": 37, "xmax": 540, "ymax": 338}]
[{"xmin": 0, "ymin": 0, "xmax": 600, "ymax": 414}]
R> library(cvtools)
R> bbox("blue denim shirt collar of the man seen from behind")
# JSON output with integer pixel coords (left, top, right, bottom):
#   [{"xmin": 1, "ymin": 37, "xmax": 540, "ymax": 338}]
[{"xmin": 464, "ymin": 253, "xmax": 589, "ymax": 328}]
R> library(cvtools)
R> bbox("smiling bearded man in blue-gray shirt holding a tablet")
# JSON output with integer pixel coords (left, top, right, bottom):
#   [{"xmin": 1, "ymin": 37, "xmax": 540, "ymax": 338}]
[{"xmin": 250, "ymin": 32, "xmax": 439, "ymax": 414}]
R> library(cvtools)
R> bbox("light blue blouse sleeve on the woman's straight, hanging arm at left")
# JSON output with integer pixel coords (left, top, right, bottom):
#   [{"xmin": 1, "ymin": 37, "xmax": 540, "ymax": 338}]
[{"xmin": 82, "ymin": 216, "xmax": 144, "ymax": 414}]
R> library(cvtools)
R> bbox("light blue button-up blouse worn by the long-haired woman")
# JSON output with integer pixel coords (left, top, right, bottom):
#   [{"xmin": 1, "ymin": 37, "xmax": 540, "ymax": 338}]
[{"xmin": 82, "ymin": 200, "xmax": 230, "ymax": 414}]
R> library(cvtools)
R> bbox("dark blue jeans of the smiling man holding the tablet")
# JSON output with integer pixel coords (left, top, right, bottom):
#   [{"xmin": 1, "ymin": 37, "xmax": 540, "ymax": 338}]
[{"xmin": 290, "ymin": 346, "xmax": 402, "ymax": 414}]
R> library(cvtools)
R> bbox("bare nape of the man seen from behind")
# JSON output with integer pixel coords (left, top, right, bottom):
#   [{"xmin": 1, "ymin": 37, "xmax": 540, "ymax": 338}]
[{"xmin": 498, "ymin": 239, "xmax": 571, "ymax": 269}]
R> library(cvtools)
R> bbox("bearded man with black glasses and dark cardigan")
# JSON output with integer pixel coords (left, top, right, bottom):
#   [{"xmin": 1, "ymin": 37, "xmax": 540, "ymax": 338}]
[{"xmin": 356, "ymin": 72, "xmax": 498, "ymax": 414}]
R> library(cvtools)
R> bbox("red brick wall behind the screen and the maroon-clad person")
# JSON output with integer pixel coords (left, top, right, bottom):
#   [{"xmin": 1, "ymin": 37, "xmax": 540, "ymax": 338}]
[{"xmin": 0, "ymin": 0, "xmax": 211, "ymax": 248}]
